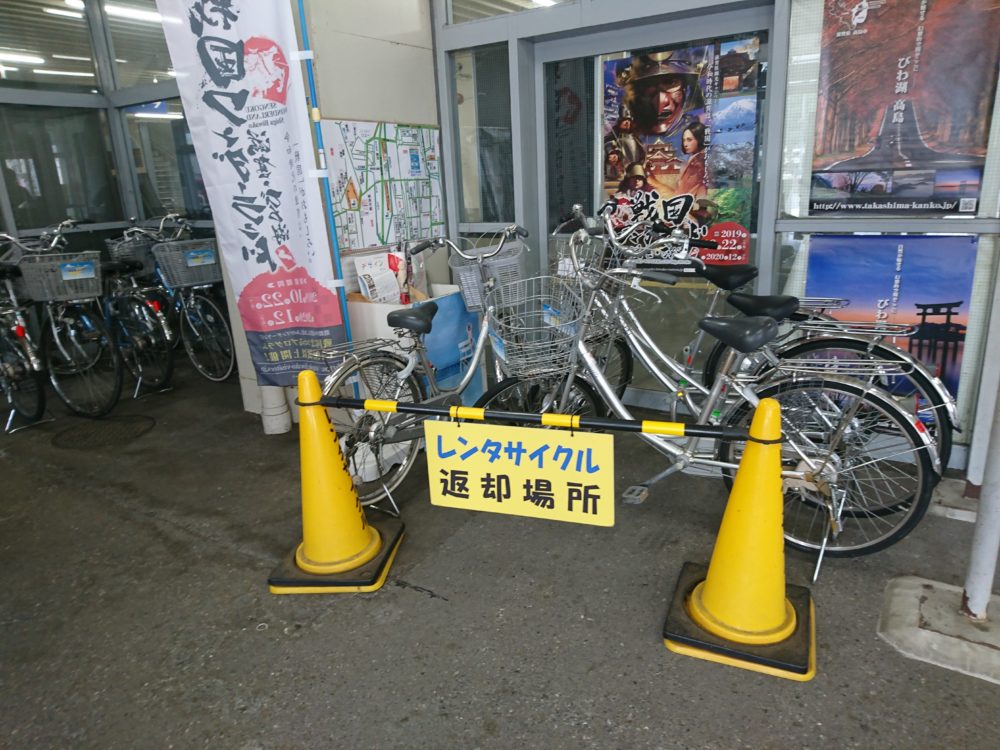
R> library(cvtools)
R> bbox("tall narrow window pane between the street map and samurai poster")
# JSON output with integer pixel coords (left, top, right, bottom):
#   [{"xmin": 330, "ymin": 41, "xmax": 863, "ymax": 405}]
[{"xmin": 452, "ymin": 44, "xmax": 514, "ymax": 223}]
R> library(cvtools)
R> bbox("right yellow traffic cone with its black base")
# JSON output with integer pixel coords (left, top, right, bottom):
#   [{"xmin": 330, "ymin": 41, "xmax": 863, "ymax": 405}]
[{"xmin": 664, "ymin": 399, "xmax": 816, "ymax": 681}]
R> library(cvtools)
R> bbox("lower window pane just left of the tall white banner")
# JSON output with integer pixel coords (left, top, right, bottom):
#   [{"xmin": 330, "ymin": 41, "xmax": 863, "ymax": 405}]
[{"xmin": 124, "ymin": 99, "xmax": 212, "ymax": 219}]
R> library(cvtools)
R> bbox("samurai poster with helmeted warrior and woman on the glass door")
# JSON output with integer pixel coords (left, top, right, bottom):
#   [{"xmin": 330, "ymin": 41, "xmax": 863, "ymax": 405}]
[{"xmin": 602, "ymin": 36, "xmax": 760, "ymax": 264}]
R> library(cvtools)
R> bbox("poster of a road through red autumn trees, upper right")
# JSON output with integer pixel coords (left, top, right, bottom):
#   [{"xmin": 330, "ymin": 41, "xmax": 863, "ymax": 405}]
[{"xmin": 810, "ymin": 0, "xmax": 1000, "ymax": 216}]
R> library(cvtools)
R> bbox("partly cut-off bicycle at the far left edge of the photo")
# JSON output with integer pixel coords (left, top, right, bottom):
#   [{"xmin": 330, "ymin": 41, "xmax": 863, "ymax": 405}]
[{"xmin": 0, "ymin": 256, "xmax": 45, "ymax": 432}]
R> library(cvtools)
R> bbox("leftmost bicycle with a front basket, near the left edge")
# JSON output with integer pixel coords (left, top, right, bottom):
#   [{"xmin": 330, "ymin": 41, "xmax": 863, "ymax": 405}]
[{"xmin": 0, "ymin": 220, "xmax": 122, "ymax": 418}]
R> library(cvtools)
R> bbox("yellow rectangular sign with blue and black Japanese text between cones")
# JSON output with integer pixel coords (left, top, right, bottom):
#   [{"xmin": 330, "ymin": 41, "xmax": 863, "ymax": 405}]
[{"xmin": 424, "ymin": 420, "xmax": 615, "ymax": 526}]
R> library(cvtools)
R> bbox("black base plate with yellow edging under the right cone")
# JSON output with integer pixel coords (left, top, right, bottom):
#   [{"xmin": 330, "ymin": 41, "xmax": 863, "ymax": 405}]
[{"xmin": 663, "ymin": 562, "xmax": 816, "ymax": 682}]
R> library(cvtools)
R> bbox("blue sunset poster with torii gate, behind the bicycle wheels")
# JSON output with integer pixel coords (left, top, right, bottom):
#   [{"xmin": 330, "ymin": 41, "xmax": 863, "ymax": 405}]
[{"xmin": 806, "ymin": 235, "xmax": 978, "ymax": 395}]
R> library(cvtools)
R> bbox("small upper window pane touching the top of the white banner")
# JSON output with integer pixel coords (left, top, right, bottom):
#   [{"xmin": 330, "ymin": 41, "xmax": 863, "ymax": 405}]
[{"xmin": 104, "ymin": 0, "xmax": 173, "ymax": 88}]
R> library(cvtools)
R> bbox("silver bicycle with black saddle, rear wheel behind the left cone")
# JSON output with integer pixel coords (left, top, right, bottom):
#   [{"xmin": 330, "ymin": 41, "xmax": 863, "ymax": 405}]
[{"xmin": 317, "ymin": 225, "xmax": 560, "ymax": 505}]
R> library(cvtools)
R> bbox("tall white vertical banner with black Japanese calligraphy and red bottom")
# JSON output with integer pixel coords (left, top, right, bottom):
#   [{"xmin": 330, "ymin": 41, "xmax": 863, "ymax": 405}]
[{"xmin": 157, "ymin": 0, "xmax": 344, "ymax": 385}]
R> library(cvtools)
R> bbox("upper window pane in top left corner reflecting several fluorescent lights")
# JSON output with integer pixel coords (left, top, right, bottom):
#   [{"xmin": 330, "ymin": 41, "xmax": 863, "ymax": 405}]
[{"xmin": 0, "ymin": 0, "xmax": 97, "ymax": 91}]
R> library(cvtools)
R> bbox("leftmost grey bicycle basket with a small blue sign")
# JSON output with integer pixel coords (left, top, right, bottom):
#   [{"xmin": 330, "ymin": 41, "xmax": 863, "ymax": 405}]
[{"xmin": 17, "ymin": 250, "xmax": 102, "ymax": 302}]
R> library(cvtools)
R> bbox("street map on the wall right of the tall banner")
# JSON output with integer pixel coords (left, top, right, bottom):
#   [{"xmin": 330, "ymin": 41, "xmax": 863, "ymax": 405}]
[{"xmin": 320, "ymin": 120, "xmax": 445, "ymax": 249}]
